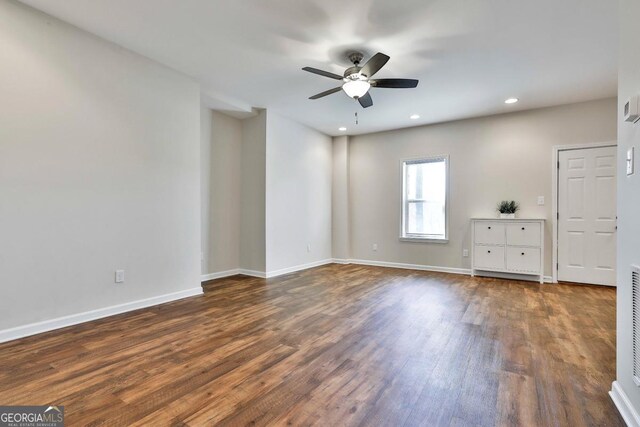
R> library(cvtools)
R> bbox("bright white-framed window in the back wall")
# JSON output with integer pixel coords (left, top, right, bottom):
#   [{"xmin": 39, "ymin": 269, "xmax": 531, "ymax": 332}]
[{"xmin": 400, "ymin": 156, "xmax": 449, "ymax": 241}]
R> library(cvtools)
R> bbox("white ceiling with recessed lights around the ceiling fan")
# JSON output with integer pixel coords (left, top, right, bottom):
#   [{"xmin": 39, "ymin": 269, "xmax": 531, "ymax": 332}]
[{"xmin": 23, "ymin": 0, "xmax": 618, "ymax": 135}]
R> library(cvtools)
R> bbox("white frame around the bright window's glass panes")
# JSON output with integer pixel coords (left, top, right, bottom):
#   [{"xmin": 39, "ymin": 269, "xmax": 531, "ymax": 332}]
[{"xmin": 400, "ymin": 155, "xmax": 450, "ymax": 243}]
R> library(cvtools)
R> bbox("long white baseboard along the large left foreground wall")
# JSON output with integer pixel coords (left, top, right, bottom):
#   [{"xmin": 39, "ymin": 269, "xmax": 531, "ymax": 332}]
[{"xmin": 0, "ymin": 286, "xmax": 202, "ymax": 343}]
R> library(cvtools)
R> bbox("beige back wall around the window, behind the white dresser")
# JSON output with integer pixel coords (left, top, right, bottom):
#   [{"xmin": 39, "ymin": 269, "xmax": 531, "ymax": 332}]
[{"xmin": 349, "ymin": 99, "xmax": 616, "ymax": 275}]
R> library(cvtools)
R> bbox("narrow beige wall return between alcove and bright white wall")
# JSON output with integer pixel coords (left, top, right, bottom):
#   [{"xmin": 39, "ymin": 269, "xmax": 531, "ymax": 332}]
[{"xmin": 240, "ymin": 110, "xmax": 267, "ymax": 273}]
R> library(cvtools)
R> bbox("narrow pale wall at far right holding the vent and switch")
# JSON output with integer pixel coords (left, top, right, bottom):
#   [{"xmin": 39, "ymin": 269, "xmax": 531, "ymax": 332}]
[{"xmin": 614, "ymin": 0, "xmax": 640, "ymax": 422}]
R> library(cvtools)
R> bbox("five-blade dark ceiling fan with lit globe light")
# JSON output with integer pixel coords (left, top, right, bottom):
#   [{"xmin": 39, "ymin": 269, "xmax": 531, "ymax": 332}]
[{"xmin": 303, "ymin": 52, "xmax": 418, "ymax": 108}]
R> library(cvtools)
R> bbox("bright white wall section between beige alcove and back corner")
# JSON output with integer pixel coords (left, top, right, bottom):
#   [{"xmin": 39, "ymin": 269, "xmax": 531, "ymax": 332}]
[{"xmin": 266, "ymin": 111, "xmax": 332, "ymax": 273}]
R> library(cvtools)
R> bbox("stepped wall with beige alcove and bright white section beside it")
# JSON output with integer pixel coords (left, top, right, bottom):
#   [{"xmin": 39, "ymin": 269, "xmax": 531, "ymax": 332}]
[{"xmin": 201, "ymin": 107, "xmax": 332, "ymax": 275}]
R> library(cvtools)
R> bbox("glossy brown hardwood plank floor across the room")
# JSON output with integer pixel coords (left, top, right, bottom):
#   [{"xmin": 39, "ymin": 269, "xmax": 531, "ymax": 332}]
[{"xmin": 0, "ymin": 265, "xmax": 624, "ymax": 426}]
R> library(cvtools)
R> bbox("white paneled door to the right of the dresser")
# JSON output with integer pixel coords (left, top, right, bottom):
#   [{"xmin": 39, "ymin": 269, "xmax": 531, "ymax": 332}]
[{"xmin": 558, "ymin": 147, "xmax": 616, "ymax": 286}]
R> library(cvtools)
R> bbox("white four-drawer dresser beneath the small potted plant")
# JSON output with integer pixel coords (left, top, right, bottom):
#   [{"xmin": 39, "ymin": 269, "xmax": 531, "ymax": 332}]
[{"xmin": 471, "ymin": 218, "xmax": 545, "ymax": 283}]
